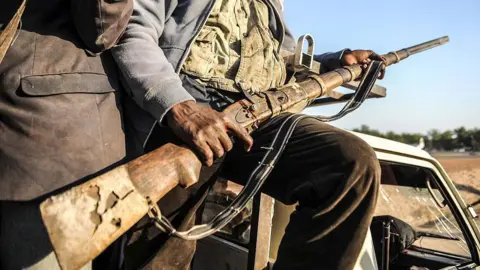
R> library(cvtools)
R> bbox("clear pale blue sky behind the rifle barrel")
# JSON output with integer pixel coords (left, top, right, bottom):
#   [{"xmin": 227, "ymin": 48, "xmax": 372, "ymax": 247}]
[{"xmin": 285, "ymin": 0, "xmax": 480, "ymax": 132}]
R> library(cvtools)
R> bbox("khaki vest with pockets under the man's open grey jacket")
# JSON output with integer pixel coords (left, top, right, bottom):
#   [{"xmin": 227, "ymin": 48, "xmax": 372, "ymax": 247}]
[{"xmin": 182, "ymin": 0, "xmax": 286, "ymax": 93}]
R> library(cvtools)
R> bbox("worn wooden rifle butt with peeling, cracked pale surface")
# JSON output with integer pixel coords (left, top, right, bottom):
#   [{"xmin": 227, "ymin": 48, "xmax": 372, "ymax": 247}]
[{"xmin": 40, "ymin": 143, "xmax": 201, "ymax": 269}]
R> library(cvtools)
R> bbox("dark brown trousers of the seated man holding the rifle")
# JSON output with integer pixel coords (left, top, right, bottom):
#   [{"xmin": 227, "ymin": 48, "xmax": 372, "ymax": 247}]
[{"xmin": 121, "ymin": 75, "xmax": 380, "ymax": 270}]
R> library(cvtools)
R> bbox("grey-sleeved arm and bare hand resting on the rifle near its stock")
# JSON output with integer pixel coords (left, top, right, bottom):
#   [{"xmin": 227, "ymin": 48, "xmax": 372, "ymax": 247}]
[{"xmin": 113, "ymin": 0, "xmax": 253, "ymax": 166}]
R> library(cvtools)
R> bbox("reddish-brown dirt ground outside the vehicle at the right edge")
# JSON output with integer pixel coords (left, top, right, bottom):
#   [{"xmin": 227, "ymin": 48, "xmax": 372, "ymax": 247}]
[{"xmin": 436, "ymin": 156, "xmax": 480, "ymax": 226}]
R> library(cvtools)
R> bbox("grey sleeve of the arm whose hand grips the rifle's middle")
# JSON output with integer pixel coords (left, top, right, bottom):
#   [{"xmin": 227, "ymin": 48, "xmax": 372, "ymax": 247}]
[{"xmin": 112, "ymin": 0, "xmax": 195, "ymax": 121}]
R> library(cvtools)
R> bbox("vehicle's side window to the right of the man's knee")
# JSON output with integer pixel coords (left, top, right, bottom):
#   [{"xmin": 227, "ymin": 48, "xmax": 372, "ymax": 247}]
[{"xmin": 375, "ymin": 163, "xmax": 470, "ymax": 257}]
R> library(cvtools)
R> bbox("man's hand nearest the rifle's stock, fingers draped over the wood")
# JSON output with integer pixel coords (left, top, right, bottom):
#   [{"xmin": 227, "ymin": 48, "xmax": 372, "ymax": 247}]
[{"xmin": 167, "ymin": 101, "xmax": 253, "ymax": 166}]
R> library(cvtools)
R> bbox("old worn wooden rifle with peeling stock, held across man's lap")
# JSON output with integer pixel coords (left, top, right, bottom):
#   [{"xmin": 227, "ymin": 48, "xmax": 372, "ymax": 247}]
[{"xmin": 40, "ymin": 37, "xmax": 449, "ymax": 269}]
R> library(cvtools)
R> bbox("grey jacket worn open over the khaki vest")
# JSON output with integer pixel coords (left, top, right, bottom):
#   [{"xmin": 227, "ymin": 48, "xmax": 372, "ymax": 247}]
[{"xmin": 112, "ymin": 0, "xmax": 341, "ymax": 124}]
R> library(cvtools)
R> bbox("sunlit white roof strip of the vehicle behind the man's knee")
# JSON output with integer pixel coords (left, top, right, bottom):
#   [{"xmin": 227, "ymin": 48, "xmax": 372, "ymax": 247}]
[{"xmin": 349, "ymin": 131, "xmax": 432, "ymax": 159}]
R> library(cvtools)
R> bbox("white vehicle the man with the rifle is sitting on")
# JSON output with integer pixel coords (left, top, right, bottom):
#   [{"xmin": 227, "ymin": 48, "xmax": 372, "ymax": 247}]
[{"xmin": 193, "ymin": 133, "xmax": 480, "ymax": 270}]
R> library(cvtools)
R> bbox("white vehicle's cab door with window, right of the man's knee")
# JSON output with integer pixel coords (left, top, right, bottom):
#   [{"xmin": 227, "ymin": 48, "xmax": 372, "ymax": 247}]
[{"xmin": 371, "ymin": 151, "xmax": 479, "ymax": 270}]
